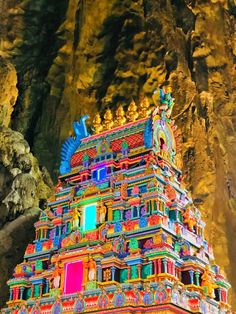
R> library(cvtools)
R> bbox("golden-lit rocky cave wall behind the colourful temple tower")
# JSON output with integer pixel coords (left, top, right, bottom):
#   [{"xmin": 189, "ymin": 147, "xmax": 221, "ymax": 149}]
[{"xmin": 0, "ymin": 0, "xmax": 236, "ymax": 310}]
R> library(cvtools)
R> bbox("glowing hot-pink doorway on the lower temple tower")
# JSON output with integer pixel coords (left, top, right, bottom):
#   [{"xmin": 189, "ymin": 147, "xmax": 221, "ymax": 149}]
[{"xmin": 64, "ymin": 261, "xmax": 83, "ymax": 294}]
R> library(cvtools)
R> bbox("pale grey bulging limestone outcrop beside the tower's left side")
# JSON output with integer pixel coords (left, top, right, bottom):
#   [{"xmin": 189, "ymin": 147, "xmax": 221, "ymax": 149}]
[{"xmin": 0, "ymin": 128, "xmax": 52, "ymax": 302}]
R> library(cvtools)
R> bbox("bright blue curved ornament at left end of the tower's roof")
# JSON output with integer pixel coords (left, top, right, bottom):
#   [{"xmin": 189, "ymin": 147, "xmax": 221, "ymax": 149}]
[{"xmin": 60, "ymin": 115, "xmax": 89, "ymax": 174}]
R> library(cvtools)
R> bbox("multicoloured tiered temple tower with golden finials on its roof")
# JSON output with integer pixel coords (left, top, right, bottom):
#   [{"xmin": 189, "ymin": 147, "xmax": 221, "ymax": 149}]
[{"xmin": 2, "ymin": 87, "xmax": 231, "ymax": 314}]
